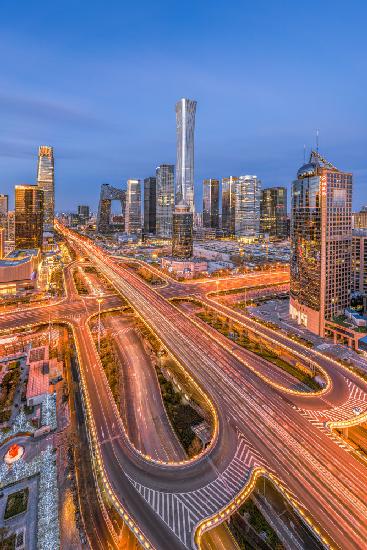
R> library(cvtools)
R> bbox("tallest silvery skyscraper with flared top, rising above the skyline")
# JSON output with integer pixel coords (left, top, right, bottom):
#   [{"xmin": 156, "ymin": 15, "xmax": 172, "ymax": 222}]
[{"xmin": 176, "ymin": 98, "xmax": 196, "ymax": 212}]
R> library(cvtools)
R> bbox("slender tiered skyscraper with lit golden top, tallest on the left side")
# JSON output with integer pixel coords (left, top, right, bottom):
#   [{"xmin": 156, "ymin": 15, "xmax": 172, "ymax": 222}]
[{"xmin": 37, "ymin": 145, "xmax": 55, "ymax": 231}]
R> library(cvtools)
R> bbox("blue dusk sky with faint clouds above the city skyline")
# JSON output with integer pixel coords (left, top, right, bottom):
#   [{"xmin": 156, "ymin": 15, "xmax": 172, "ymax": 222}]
[{"xmin": 0, "ymin": 0, "xmax": 367, "ymax": 210}]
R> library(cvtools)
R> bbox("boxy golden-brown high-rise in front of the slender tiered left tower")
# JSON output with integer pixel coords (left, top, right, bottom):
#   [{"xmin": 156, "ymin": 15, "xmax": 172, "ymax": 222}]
[{"xmin": 15, "ymin": 185, "xmax": 44, "ymax": 248}]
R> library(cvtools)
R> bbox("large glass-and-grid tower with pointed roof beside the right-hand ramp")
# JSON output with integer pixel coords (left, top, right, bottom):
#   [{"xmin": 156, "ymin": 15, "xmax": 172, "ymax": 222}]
[{"xmin": 290, "ymin": 151, "xmax": 352, "ymax": 336}]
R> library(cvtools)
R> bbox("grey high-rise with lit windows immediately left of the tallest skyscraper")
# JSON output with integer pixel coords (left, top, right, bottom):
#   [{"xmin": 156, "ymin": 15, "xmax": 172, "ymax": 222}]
[{"xmin": 156, "ymin": 164, "xmax": 175, "ymax": 238}]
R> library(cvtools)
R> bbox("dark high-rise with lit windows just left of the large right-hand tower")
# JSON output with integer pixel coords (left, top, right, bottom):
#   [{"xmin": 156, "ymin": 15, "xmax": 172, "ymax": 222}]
[{"xmin": 260, "ymin": 187, "xmax": 287, "ymax": 239}]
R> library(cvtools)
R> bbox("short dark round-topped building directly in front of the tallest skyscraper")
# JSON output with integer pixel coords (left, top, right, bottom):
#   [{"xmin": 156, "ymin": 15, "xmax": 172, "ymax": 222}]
[{"xmin": 172, "ymin": 202, "xmax": 193, "ymax": 260}]
